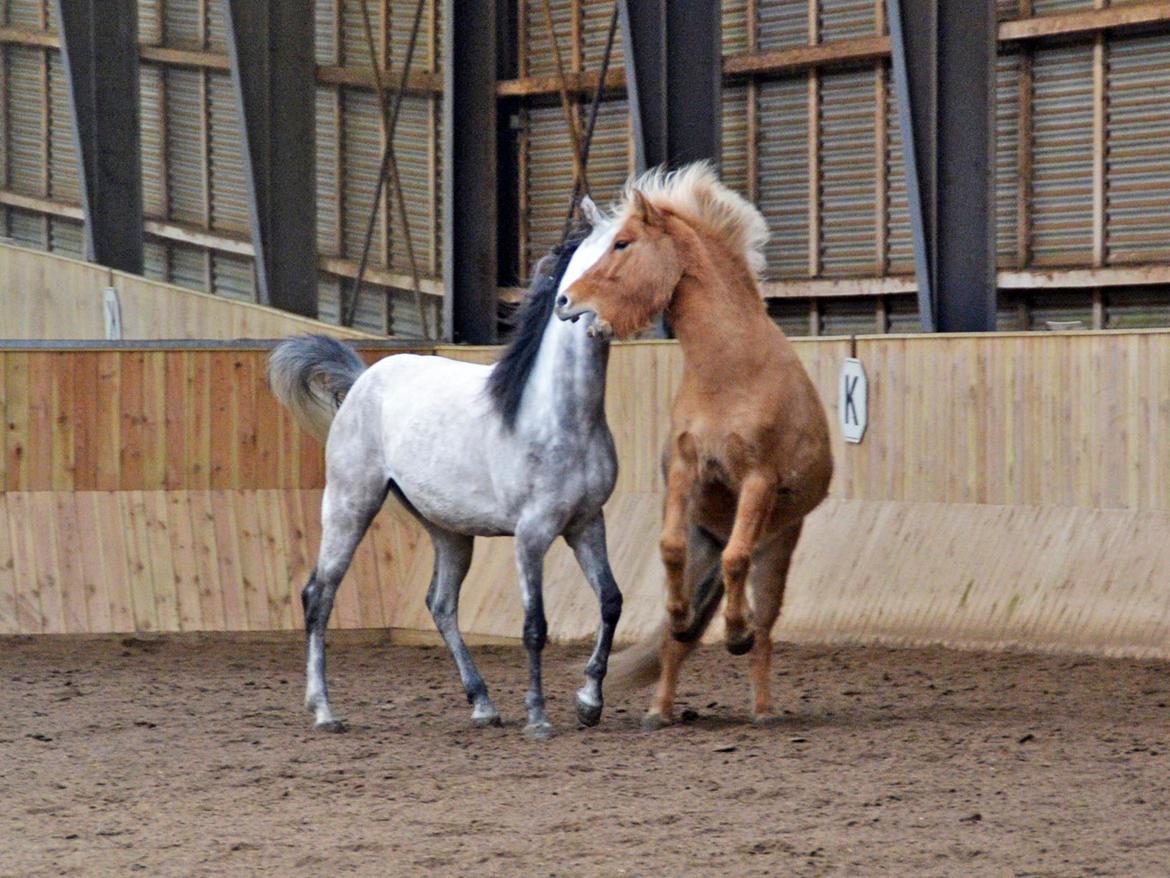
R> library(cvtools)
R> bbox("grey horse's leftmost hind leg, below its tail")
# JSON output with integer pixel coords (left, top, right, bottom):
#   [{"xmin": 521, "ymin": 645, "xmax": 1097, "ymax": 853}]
[{"xmin": 301, "ymin": 480, "xmax": 386, "ymax": 732}]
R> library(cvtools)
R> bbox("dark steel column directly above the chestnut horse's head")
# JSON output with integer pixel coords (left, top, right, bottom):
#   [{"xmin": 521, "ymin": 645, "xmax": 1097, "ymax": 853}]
[{"xmin": 621, "ymin": 0, "xmax": 723, "ymax": 171}]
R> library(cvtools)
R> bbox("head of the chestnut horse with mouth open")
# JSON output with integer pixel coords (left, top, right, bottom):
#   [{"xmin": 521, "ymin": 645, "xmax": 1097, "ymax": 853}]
[{"xmin": 557, "ymin": 188, "xmax": 683, "ymax": 338}]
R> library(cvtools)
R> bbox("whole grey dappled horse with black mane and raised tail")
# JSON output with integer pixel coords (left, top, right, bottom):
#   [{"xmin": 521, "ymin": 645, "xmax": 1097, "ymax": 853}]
[{"xmin": 268, "ymin": 201, "xmax": 621, "ymax": 738}]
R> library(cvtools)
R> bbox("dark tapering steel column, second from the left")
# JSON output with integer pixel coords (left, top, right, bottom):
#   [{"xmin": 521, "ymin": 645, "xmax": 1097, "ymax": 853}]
[{"xmin": 223, "ymin": 0, "xmax": 317, "ymax": 317}]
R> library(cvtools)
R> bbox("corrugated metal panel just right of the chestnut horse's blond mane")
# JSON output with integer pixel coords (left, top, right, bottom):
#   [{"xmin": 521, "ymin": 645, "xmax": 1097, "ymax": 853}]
[{"xmin": 758, "ymin": 78, "xmax": 808, "ymax": 277}]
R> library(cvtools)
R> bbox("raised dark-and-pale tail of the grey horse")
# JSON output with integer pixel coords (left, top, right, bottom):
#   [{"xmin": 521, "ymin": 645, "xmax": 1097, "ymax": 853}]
[{"xmin": 268, "ymin": 335, "xmax": 366, "ymax": 441}]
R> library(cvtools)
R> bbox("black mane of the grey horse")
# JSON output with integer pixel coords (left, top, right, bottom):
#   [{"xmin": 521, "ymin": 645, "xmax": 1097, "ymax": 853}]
[{"xmin": 488, "ymin": 218, "xmax": 593, "ymax": 430}]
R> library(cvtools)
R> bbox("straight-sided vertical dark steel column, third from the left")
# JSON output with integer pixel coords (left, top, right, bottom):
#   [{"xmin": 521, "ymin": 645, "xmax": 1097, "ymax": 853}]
[{"xmin": 442, "ymin": 0, "xmax": 498, "ymax": 344}]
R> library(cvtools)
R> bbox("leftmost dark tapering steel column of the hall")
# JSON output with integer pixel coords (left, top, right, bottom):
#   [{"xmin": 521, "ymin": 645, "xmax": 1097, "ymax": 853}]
[{"xmin": 53, "ymin": 0, "xmax": 143, "ymax": 274}]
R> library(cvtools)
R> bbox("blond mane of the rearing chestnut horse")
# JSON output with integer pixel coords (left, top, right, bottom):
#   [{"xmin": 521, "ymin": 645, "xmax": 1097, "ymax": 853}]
[{"xmin": 614, "ymin": 162, "xmax": 769, "ymax": 279}]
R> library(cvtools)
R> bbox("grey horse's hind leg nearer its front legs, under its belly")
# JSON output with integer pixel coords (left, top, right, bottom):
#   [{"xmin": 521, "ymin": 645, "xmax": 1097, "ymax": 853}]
[{"xmin": 427, "ymin": 528, "xmax": 500, "ymax": 726}]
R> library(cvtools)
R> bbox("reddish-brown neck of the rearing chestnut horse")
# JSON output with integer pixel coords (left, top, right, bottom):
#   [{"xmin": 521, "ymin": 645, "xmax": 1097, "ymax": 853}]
[{"xmin": 667, "ymin": 221, "xmax": 776, "ymax": 384}]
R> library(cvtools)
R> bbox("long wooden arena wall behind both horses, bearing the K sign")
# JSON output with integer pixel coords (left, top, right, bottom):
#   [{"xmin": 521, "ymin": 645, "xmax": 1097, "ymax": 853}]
[{"xmin": 0, "ymin": 331, "xmax": 1170, "ymax": 656}]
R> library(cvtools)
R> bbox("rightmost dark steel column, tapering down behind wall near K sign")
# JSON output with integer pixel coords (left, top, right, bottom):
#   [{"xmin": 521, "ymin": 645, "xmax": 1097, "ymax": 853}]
[{"xmin": 887, "ymin": 0, "xmax": 996, "ymax": 332}]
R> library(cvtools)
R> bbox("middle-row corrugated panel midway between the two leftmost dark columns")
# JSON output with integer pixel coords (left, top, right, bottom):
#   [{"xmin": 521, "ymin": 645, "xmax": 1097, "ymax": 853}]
[{"xmin": 164, "ymin": 68, "xmax": 206, "ymax": 225}]
